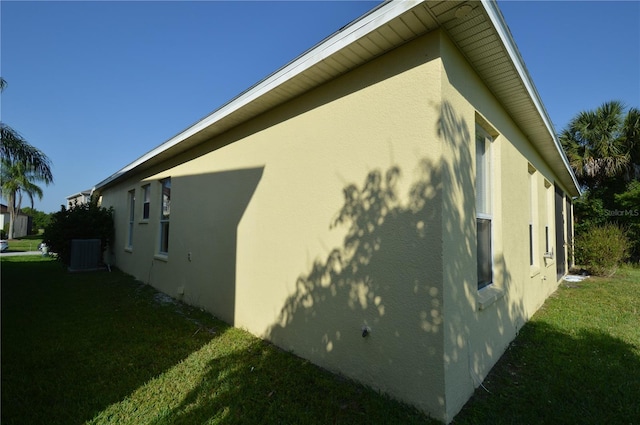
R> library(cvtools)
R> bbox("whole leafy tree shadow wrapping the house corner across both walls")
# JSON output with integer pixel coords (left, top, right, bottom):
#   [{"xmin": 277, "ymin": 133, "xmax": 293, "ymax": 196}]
[{"xmin": 267, "ymin": 102, "xmax": 523, "ymax": 412}]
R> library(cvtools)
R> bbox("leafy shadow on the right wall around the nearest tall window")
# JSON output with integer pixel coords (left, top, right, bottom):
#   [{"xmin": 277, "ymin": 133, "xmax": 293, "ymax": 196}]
[{"xmin": 433, "ymin": 101, "xmax": 526, "ymax": 387}]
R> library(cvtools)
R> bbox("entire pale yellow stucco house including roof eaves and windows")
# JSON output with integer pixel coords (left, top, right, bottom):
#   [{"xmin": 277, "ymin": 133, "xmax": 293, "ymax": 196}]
[{"xmin": 95, "ymin": 1, "xmax": 579, "ymax": 422}]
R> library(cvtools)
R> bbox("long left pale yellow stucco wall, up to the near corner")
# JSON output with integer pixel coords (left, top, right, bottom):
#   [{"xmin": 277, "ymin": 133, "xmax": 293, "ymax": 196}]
[{"xmin": 103, "ymin": 33, "xmax": 445, "ymax": 417}]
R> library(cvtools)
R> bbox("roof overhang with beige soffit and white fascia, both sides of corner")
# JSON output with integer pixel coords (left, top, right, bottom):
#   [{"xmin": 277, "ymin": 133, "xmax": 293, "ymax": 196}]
[{"xmin": 94, "ymin": 0, "xmax": 579, "ymax": 196}]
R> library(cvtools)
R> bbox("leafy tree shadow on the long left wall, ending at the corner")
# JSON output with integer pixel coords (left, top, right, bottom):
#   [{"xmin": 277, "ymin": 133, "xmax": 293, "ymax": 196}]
[{"xmin": 267, "ymin": 158, "xmax": 443, "ymax": 408}]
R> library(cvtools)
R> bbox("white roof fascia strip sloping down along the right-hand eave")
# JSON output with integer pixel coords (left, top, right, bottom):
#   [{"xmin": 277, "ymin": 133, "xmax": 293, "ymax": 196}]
[{"xmin": 481, "ymin": 0, "xmax": 582, "ymax": 194}]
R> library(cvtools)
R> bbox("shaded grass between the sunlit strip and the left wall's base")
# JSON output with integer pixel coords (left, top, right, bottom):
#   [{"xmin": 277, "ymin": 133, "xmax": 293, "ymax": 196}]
[{"xmin": 141, "ymin": 340, "xmax": 437, "ymax": 425}]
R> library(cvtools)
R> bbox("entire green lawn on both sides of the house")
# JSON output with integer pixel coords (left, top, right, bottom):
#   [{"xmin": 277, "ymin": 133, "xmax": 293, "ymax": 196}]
[{"xmin": 1, "ymin": 256, "xmax": 640, "ymax": 425}]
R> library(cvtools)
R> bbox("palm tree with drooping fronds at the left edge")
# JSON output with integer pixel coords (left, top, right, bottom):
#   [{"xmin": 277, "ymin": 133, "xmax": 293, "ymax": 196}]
[{"xmin": 0, "ymin": 77, "xmax": 53, "ymax": 239}]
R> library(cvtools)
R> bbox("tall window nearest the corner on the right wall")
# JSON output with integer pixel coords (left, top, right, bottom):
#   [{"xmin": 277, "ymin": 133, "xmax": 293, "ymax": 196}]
[{"xmin": 476, "ymin": 127, "xmax": 493, "ymax": 289}]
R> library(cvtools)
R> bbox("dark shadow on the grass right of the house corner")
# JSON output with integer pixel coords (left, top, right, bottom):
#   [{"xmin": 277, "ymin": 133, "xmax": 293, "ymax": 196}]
[{"xmin": 454, "ymin": 322, "xmax": 640, "ymax": 425}]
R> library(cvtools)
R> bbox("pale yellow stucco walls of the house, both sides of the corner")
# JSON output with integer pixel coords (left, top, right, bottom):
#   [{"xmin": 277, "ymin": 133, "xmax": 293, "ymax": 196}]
[{"xmin": 102, "ymin": 28, "xmax": 576, "ymax": 421}]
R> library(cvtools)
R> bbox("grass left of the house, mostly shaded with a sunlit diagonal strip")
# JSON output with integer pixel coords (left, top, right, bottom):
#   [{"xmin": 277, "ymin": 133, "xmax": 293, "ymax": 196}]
[{"xmin": 1, "ymin": 256, "xmax": 435, "ymax": 425}]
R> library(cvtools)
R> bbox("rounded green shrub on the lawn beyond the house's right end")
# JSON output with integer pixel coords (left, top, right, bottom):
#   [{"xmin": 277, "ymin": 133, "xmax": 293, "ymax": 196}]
[{"xmin": 575, "ymin": 223, "xmax": 630, "ymax": 276}]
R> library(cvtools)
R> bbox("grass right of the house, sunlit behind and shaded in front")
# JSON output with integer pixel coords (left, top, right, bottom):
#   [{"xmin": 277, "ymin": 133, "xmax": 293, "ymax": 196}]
[{"xmin": 454, "ymin": 267, "xmax": 640, "ymax": 424}]
